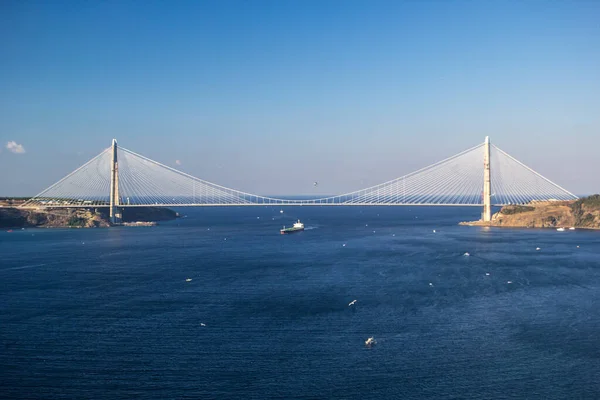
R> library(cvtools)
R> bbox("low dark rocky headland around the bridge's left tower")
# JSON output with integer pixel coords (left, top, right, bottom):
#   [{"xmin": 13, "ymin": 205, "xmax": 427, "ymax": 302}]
[{"xmin": 0, "ymin": 207, "xmax": 178, "ymax": 228}]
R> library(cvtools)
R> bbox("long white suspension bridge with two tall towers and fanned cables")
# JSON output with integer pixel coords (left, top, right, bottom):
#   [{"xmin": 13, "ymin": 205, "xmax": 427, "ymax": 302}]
[{"xmin": 21, "ymin": 137, "xmax": 577, "ymax": 223}]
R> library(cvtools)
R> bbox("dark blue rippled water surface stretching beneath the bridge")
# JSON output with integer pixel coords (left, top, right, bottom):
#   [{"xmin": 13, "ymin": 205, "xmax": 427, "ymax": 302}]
[{"xmin": 0, "ymin": 207, "xmax": 600, "ymax": 399}]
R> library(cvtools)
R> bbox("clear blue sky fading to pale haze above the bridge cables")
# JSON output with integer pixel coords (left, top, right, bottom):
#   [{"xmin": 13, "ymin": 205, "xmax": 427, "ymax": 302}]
[{"xmin": 0, "ymin": 0, "xmax": 600, "ymax": 196}]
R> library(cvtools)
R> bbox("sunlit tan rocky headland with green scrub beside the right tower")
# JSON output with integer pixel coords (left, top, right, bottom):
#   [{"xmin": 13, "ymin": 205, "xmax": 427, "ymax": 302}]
[{"xmin": 460, "ymin": 194, "xmax": 600, "ymax": 229}]
